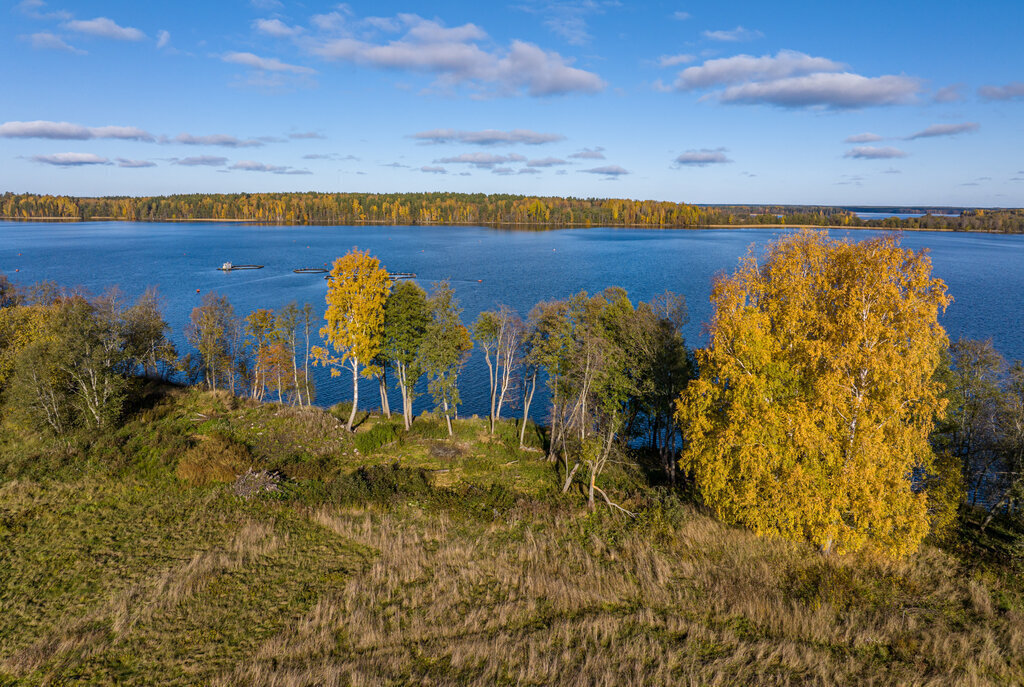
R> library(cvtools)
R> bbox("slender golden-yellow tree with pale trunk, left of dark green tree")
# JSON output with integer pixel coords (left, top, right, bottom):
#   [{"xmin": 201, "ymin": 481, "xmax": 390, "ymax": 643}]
[{"xmin": 313, "ymin": 248, "xmax": 391, "ymax": 431}]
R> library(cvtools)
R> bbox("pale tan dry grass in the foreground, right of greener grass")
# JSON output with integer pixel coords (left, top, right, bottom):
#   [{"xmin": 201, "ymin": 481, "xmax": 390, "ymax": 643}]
[{"xmin": 214, "ymin": 510, "xmax": 1024, "ymax": 686}]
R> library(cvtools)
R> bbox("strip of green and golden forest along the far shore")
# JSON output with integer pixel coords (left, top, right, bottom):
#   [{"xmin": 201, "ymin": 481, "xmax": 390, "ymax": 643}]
[{"xmin": 0, "ymin": 192, "xmax": 1024, "ymax": 233}]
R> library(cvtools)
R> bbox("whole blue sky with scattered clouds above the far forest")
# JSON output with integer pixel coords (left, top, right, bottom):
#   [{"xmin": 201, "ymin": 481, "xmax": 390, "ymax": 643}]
[{"xmin": 0, "ymin": 0, "xmax": 1024, "ymax": 207}]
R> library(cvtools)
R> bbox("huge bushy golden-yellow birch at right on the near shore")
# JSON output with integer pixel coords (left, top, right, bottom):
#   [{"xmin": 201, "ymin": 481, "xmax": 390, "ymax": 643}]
[{"xmin": 677, "ymin": 231, "xmax": 950, "ymax": 555}]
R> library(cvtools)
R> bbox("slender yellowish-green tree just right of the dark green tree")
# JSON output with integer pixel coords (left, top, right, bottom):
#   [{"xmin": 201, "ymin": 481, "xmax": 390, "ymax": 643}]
[{"xmin": 418, "ymin": 282, "xmax": 473, "ymax": 436}]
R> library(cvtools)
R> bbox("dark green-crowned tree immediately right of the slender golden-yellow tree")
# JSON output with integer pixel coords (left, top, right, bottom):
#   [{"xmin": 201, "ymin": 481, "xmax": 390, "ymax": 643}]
[{"xmin": 383, "ymin": 282, "xmax": 430, "ymax": 430}]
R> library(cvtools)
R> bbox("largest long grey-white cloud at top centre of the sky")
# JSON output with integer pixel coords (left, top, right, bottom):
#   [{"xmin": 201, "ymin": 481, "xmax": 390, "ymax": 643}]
[{"xmin": 303, "ymin": 14, "xmax": 605, "ymax": 96}]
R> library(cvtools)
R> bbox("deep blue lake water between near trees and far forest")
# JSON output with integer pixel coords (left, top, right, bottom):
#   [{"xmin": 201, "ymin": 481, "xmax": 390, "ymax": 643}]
[{"xmin": 0, "ymin": 222, "xmax": 1024, "ymax": 419}]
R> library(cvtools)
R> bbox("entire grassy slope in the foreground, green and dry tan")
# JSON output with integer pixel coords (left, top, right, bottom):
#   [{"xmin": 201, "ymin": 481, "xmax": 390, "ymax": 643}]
[{"xmin": 0, "ymin": 389, "xmax": 1024, "ymax": 685}]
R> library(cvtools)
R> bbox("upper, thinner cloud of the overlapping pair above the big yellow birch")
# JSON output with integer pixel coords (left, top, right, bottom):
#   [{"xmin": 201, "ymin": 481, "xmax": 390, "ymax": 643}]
[{"xmin": 676, "ymin": 50, "xmax": 846, "ymax": 90}]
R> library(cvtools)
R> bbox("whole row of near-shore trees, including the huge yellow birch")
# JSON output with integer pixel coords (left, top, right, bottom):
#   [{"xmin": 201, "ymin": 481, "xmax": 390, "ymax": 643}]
[{"xmin": 0, "ymin": 231, "xmax": 1024, "ymax": 556}]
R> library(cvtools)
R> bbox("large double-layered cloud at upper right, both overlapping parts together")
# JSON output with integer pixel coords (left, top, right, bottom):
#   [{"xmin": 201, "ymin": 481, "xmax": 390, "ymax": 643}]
[{"xmin": 675, "ymin": 50, "xmax": 922, "ymax": 109}]
